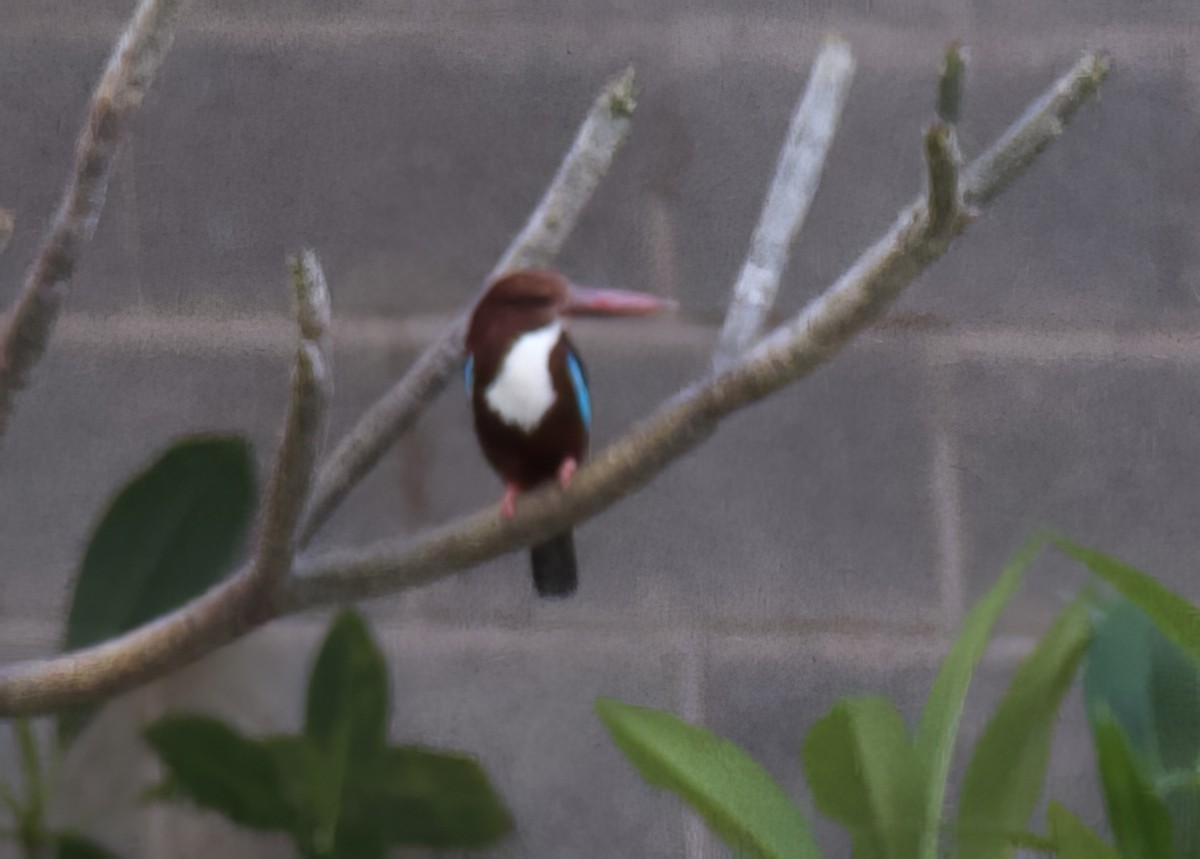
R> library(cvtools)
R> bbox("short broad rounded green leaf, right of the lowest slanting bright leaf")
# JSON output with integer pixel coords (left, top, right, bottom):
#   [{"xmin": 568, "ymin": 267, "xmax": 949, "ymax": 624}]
[{"xmin": 803, "ymin": 696, "xmax": 926, "ymax": 859}]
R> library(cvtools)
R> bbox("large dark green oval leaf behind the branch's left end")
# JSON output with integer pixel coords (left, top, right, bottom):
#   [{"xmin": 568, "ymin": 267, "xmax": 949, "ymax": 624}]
[{"xmin": 59, "ymin": 435, "xmax": 256, "ymax": 744}]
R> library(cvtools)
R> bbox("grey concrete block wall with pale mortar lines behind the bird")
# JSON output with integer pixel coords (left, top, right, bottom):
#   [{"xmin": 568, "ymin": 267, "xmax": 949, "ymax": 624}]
[{"xmin": 0, "ymin": 0, "xmax": 1200, "ymax": 859}]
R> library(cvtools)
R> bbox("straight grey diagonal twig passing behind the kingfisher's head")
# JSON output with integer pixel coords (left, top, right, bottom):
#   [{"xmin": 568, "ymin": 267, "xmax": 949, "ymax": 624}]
[{"xmin": 299, "ymin": 67, "xmax": 636, "ymax": 546}]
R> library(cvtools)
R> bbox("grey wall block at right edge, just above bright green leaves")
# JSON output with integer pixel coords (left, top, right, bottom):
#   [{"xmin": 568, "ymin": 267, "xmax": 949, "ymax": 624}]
[{"xmin": 955, "ymin": 361, "xmax": 1200, "ymax": 631}]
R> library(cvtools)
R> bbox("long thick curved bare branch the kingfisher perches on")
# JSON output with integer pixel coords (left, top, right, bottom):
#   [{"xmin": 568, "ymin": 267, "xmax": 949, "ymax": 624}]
[{"xmin": 0, "ymin": 33, "xmax": 1108, "ymax": 715}]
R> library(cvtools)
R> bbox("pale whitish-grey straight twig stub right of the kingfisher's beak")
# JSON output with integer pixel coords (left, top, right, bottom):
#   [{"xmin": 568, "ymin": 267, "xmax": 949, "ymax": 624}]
[{"xmin": 714, "ymin": 37, "xmax": 854, "ymax": 370}]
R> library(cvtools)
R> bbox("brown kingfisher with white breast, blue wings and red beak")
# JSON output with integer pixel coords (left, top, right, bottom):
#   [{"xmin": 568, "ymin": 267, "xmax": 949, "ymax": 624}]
[{"xmin": 463, "ymin": 269, "xmax": 667, "ymax": 596}]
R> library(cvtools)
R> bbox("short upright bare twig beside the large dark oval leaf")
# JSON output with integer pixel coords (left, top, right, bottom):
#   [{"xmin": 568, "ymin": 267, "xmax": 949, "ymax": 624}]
[{"xmin": 253, "ymin": 251, "xmax": 332, "ymax": 599}]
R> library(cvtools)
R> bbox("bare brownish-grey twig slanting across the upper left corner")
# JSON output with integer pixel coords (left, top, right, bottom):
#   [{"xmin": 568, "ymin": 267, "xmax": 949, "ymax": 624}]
[{"xmin": 0, "ymin": 0, "xmax": 186, "ymax": 435}]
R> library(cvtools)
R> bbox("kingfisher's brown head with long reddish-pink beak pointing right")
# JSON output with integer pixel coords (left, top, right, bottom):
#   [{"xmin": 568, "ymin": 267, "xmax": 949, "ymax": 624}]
[{"xmin": 467, "ymin": 269, "xmax": 668, "ymax": 353}]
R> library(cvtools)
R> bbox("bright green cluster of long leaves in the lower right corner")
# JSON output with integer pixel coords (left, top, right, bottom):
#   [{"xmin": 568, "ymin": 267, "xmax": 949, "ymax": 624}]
[{"xmin": 596, "ymin": 533, "xmax": 1200, "ymax": 859}]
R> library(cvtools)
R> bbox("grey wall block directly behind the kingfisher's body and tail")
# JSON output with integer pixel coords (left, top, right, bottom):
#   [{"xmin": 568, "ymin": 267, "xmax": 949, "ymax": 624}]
[{"xmin": 408, "ymin": 338, "xmax": 937, "ymax": 625}]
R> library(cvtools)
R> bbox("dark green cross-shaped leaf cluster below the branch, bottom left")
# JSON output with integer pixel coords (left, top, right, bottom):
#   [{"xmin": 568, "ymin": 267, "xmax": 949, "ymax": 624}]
[{"xmin": 145, "ymin": 611, "xmax": 512, "ymax": 859}]
